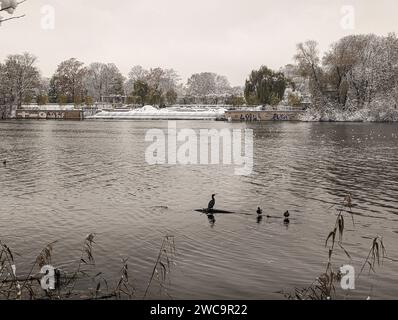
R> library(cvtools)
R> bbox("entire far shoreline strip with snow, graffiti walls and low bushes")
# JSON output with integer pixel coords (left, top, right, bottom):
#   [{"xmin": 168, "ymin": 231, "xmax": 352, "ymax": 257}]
[{"xmin": 0, "ymin": 105, "xmax": 398, "ymax": 123}]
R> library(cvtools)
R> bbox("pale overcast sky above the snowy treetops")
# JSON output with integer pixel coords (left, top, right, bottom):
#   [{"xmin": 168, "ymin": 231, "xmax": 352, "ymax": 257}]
[{"xmin": 0, "ymin": 0, "xmax": 398, "ymax": 85}]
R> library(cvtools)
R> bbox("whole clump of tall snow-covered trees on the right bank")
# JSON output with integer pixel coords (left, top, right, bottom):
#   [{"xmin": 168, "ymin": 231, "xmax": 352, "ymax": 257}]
[{"xmin": 296, "ymin": 33, "xmax": 398, "ymax": 120}]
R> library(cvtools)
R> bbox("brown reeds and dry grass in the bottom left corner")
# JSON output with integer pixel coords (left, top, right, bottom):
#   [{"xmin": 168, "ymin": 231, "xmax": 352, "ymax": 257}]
[{"xmin": 0, "ymin": 234, "xmax": 175, "ymax": 300}]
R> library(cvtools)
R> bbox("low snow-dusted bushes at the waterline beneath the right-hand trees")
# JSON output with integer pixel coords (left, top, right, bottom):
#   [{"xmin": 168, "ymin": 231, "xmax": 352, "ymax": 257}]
[{"xmin": 300, "ymin": 107, "xmax": 398, "ymax": 122}]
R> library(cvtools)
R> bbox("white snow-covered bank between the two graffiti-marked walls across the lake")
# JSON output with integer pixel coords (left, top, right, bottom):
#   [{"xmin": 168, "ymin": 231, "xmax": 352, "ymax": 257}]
[{"xmin": 86, "ymin": 106, "xmax": 226, "ymax": 120}]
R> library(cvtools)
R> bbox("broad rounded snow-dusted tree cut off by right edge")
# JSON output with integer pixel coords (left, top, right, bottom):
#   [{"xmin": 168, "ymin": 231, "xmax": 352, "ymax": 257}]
[{"xmin": 326, "ymin": 34, "xmax": 398, "ymax": 109}]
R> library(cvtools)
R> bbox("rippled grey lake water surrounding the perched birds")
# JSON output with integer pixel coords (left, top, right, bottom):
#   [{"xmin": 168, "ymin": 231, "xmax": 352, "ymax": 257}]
[{"xmin": 0, "ymin": 121, "xmax": 398, "ymax": 299}]
